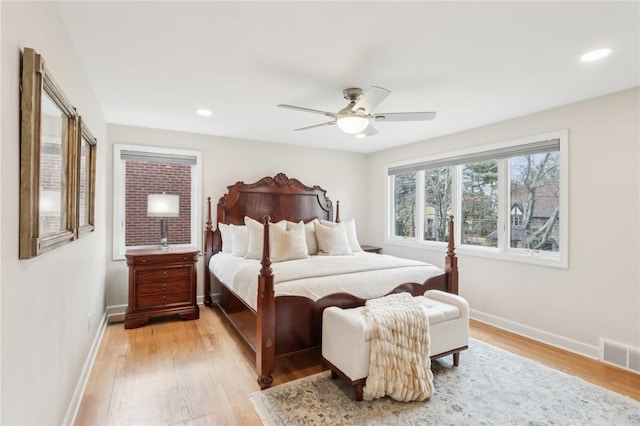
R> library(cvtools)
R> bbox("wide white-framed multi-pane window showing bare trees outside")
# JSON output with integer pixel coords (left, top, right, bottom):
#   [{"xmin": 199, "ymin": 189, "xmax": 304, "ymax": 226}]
[{"xmin": 387, "ymin": 131, "xmax": 568, "ymax": 267}]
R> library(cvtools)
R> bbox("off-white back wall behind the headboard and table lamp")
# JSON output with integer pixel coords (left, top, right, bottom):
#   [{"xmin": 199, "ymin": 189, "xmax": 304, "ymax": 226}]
[{"xmin": 106, "ymin": 125, "xmax": 369, "ymax": 313}]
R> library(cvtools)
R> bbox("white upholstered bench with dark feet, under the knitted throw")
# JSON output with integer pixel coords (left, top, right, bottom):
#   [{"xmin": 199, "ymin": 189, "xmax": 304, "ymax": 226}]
[{"xmin": 322, "ymin": 290, "xmax": 469, "ymax": 401}]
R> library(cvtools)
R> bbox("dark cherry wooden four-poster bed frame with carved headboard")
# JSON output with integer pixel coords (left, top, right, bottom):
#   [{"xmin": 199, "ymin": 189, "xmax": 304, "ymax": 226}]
[{"xmin": 204, "ymin": 173, "xmax": 458, "ymax": 389}]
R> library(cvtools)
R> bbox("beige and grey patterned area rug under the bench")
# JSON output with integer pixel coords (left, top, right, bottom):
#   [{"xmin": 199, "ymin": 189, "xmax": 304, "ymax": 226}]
[{"xmin": 250, "ymin": 339, "xmax": 640, "ymax": 426}]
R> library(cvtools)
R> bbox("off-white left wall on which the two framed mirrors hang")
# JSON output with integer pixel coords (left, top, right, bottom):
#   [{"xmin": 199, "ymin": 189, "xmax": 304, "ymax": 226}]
[{"xmin": 0, "ymin": 2, "xmax": 107, "ymax": 425}]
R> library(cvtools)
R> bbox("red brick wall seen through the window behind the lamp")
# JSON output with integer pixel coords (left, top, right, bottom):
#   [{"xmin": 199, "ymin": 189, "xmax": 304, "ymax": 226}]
[{"xmin": 125, "ymin": 161, "xmax": 191, "ymax": 247}]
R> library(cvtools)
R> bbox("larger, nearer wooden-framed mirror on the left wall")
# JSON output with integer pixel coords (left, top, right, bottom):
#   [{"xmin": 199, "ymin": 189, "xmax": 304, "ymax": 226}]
[{"xmin": 20, "ymin": 48, "xmax": 79, "ymax": 259}]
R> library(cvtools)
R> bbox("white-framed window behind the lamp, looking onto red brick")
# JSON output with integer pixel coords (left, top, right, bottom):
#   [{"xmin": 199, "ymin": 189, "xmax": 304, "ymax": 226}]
[{"xmin": 114, "ymin": 144, "xmax": 202, "ymax": 259}]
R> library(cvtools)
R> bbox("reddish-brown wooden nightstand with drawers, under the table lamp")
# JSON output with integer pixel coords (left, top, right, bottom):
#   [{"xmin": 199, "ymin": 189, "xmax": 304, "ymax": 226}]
[{"xmin": 124, "ymin": 247, "xmax": 200, "ymax": 328}]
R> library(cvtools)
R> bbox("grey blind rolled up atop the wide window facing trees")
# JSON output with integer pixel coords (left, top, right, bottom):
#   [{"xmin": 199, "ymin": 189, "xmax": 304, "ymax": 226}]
[{"xmin": 388, "ymin": 138, "xmax": 560, "ymax": 176}]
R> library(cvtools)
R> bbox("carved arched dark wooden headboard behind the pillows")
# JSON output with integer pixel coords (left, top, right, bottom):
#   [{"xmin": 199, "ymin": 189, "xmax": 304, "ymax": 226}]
[{"xmin": 204, "ymin": 173, "xmax": 339, "ymax": 304}]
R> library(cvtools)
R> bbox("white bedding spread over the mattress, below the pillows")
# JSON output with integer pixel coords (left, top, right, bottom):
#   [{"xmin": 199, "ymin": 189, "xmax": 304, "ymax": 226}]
[{"xmin": 209, "ymin": 252, "xmax": 443, "ymax": 310}]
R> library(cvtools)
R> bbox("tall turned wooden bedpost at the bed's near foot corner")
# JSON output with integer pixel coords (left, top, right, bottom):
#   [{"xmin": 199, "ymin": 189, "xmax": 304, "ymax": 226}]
[{"xmin": 256, "ymin": 216, "xmax": 276, "ymax": 389}]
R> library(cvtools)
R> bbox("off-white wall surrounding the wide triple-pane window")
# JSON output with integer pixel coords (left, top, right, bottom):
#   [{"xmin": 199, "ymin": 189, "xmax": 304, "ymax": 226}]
[{"xmin": 369, "ymin": 87, "xmax": 640, "ymax": 357}]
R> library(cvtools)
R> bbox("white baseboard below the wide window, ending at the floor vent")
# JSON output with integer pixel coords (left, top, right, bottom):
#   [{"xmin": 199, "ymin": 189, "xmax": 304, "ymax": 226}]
[{"xmin": 469, "ymin": 309, "xmax": 600, "ymax": 360}]
